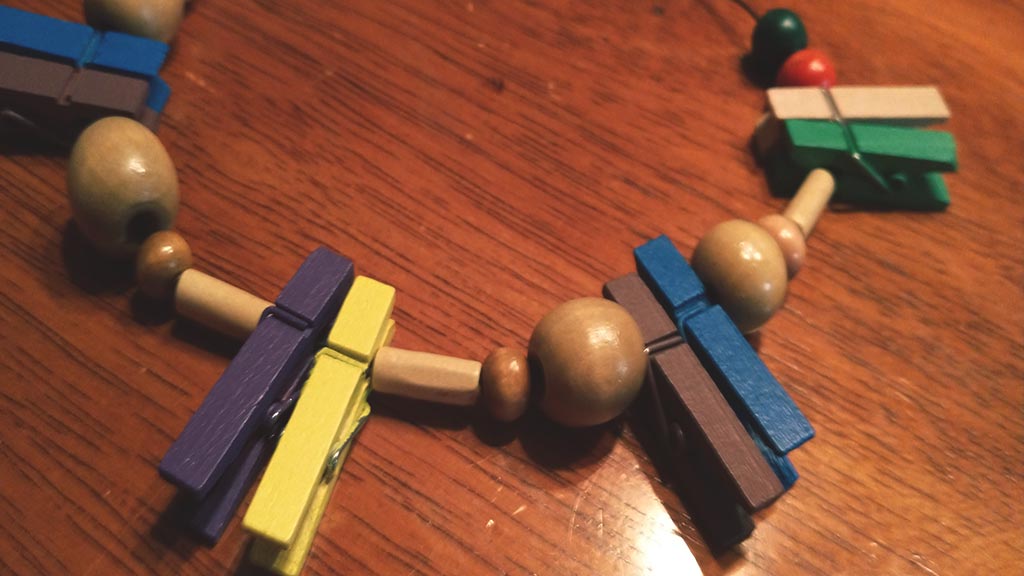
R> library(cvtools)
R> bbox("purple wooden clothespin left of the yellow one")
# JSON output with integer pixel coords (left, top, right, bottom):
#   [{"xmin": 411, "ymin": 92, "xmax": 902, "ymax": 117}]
[{"xmin": 160, "ymin": 248, "xmax": 353, "ymax": 544}]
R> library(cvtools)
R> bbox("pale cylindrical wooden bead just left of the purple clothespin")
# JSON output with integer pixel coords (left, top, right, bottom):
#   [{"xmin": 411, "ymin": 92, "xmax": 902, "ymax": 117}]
[{"xmin": 174, "ymin": 269, "xmax": 272, "ymax": 340}]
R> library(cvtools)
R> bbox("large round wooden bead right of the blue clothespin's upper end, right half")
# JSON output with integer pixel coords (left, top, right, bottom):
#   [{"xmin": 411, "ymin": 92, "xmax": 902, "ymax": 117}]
[{"xmin": 690, "ymin": 220, "xmax": 786, "ymax": 332}]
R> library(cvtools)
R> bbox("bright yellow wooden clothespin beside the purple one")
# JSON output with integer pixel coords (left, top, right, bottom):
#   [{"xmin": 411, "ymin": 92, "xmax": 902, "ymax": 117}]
[{"xmin": 242, "ymin": 276, "xmax": 395, "ymax": 576}]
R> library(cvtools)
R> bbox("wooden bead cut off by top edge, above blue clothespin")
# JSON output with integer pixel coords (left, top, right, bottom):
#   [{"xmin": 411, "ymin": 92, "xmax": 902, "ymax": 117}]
[{"xmin": 85, "ymin": 0, "xmax": 184, "ymax": 42}]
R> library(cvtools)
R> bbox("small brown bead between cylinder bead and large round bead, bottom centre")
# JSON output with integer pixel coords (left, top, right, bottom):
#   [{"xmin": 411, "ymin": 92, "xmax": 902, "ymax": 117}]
[{"xmin": 480, "ymin": 347, "xmax": 529, "ymax": 422}]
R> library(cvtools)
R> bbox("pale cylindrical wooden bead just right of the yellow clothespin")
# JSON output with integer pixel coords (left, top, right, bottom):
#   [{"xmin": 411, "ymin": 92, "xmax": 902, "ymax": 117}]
[{"xmin": 371, "ymin": 346, "xmax": 480, "ymax": 406}]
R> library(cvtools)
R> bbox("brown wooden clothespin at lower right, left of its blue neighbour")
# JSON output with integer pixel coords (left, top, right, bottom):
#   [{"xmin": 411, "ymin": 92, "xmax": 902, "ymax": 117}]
[{"xmin": 604, "ymin": 274, "xmax": 770, "ymax": 553}]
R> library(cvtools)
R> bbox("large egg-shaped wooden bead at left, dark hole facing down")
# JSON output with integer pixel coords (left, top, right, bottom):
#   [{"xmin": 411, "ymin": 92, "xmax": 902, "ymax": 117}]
[{"xmin": 68, "ymin": 117, "xmax": 178, "ymax": 256}]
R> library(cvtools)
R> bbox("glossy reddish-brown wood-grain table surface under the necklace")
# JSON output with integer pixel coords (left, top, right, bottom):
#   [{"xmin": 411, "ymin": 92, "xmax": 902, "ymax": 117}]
[{"xmin": 0, "ymin": 0, "xmax": 1024, "ymax": 575}]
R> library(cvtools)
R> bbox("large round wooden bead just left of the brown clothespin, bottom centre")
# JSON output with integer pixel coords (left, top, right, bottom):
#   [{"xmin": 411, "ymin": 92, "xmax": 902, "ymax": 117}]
[{"xmin": 529, "ymin": 298, "xmax": 647, "ymax": 426}]
